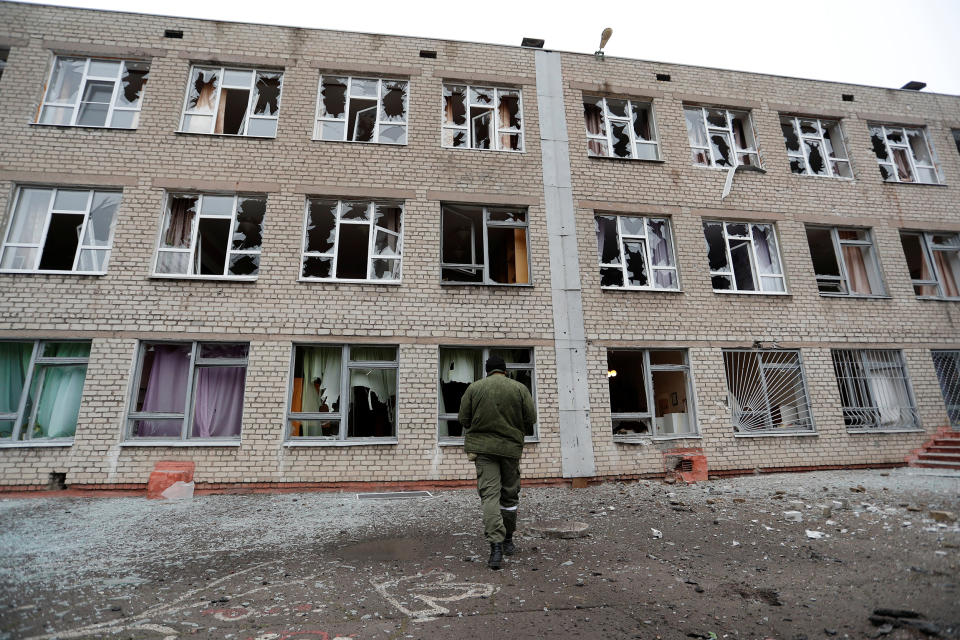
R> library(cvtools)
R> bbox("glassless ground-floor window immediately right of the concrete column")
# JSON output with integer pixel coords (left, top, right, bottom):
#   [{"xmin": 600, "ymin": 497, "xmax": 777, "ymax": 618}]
[{"xmin": 607, "ymin": 349, "xmax": 697, "ymax": 438}]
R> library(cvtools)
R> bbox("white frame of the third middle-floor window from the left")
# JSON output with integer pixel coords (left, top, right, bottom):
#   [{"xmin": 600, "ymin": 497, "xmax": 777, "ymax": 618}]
[{"xmin": 299, "ymin": 197, "xmax": 406, "ymax": 284}]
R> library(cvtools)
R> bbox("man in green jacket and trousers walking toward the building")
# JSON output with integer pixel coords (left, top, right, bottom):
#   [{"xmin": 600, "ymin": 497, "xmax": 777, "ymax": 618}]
[{"xmin": 457, "ymin": 356, "xmax": 537, "ymax": 569}]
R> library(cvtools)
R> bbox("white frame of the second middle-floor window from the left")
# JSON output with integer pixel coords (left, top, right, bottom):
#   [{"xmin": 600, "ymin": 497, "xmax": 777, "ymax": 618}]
[{"xmin": 152, "ymin": 191, "xmax": 267, "ymax": 281}]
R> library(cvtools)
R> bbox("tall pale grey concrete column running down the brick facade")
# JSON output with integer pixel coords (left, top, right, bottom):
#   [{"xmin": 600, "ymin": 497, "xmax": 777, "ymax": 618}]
[{"xmin": 536, "ymin": 51, "xmax": 596, "ymax": 478}]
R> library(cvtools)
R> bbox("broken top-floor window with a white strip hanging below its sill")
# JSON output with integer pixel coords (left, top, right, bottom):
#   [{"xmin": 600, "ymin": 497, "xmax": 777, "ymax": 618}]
[{"xmin": 683, "ymin": 106, "xmax": 760, "ymax": 169}]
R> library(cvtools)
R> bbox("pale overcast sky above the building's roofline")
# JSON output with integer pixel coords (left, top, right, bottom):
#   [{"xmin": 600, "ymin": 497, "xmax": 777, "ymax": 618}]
[{"xmin": 13, "ymin": 0, "xmax": 960, "ymax": 94}]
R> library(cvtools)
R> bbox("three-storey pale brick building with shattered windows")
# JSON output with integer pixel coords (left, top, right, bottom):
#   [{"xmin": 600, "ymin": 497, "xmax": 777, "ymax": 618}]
[{"xmin": 0, "ymin": 3, "xmax": 960, "ymax": 490}]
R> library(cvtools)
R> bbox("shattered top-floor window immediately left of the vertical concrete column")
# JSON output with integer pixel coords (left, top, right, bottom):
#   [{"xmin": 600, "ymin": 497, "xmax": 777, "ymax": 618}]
[{"xmin": 442, "ymin": 84, "xmax": 523, "ymax": 151}]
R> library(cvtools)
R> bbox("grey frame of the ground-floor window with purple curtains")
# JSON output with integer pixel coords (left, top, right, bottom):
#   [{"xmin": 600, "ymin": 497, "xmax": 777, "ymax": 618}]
[{"xmin": 123, "ymin": 340, "xmax": 250, "ymax": 446}]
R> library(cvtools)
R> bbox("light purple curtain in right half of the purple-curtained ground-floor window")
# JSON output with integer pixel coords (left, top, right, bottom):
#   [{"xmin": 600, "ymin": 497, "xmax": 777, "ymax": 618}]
[{"xmin": 193, "ymin": 367, "xmax": 247, "ymax": 438}]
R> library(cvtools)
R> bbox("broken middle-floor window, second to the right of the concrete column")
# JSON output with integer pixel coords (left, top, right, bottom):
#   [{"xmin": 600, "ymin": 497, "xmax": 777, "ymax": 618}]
[{"xmin": 703, "ymin": 222, "xmax": 787, "ymax": 293}]
